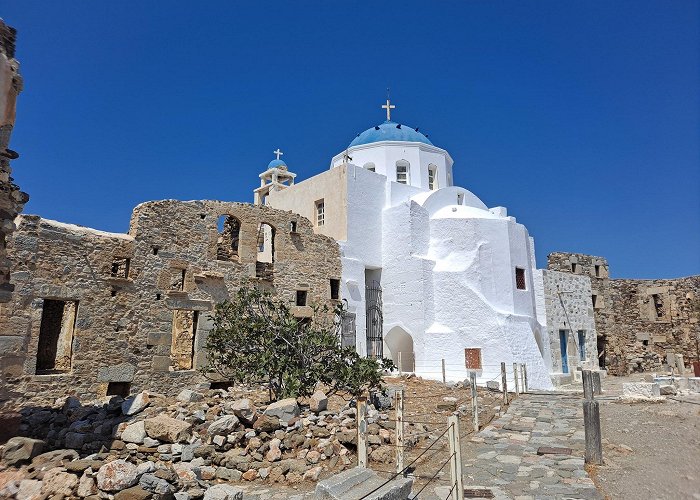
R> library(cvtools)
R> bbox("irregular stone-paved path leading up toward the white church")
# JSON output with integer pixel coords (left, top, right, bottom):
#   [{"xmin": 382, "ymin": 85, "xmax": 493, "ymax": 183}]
[{"xmin": 463, "ymin": 393, "xmax": 602, "ymax": 500}]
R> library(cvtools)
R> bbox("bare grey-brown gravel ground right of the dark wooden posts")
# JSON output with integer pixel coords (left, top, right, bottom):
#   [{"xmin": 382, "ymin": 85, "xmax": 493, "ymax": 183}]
[{"xmin": 589, "ymin": 375, "xmax": 700, "ymax": 499}]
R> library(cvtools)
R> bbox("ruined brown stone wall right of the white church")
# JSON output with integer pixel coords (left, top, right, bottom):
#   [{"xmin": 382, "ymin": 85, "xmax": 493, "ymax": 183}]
[{"xmin": 547, "ymin": 252, "xmax": 700, "ymax": 375}]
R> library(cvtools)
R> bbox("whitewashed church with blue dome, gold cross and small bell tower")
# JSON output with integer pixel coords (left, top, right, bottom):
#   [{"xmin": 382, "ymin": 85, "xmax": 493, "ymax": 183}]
[{"xmin": 255, "ymin": 99, "xmax": 597, "ymax": 389}]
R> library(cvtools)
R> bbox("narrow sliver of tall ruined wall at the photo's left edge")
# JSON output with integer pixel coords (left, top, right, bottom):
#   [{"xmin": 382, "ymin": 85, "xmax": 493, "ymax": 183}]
[{"xmin": 0, "ymin": 19, "xmax": 29, "ymax": 302}]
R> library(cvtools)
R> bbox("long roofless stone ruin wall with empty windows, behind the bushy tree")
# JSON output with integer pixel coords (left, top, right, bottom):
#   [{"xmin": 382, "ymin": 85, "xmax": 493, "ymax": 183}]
[{"xmin": 0, "ymin": 200, "xmax": 341, "ymax": 405}]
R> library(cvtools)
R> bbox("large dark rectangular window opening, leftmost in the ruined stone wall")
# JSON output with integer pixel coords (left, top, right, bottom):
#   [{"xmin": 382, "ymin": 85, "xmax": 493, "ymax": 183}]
[{"xmin": 36, "ymin": 299, "xmax": 78, "ymax": 373}]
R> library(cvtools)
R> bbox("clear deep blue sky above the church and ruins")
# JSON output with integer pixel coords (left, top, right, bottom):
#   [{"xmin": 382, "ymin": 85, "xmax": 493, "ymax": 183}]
[{"xmin": 0, "ymin": 0, "xmax": 700, "ymax": 278}]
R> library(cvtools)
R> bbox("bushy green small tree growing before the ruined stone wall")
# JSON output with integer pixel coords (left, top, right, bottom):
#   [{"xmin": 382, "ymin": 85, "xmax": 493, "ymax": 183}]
[{"xmin": 204, "ymin": 287, "xmax": 394, "ymax": 399}]
